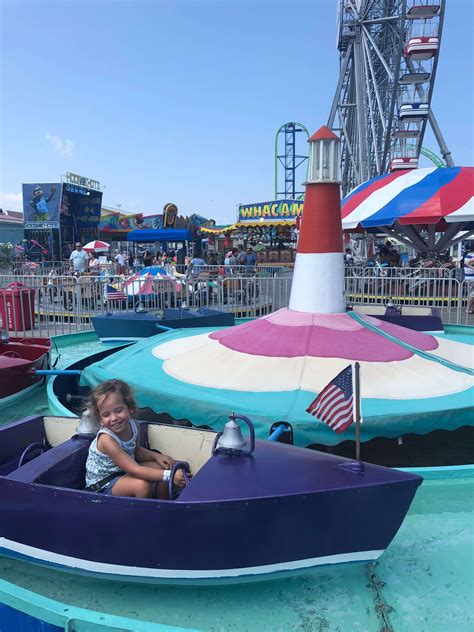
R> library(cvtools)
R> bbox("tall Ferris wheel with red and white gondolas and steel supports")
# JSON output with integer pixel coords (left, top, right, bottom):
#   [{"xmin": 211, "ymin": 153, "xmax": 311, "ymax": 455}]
[{"xmin": 328, "ymin": 0, "xmax": 454, "ymax": 195}]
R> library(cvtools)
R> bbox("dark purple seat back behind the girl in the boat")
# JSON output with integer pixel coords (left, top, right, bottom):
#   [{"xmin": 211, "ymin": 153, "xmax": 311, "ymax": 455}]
[{"xmin": 7, "ymin": 436, "xmax": 91, "ymax": 489}]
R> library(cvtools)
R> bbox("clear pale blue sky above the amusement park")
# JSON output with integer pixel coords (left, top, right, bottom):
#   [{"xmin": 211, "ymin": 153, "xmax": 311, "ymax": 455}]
[{"xmin": 0, "ymin": 0, "xmax": 474, "ymax": 223}]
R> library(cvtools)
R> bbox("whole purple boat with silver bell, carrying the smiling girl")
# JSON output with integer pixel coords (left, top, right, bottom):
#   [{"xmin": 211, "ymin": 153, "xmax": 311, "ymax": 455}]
[{"xmin": 0, "ymin": 416, "xmax": 422, "ymax": 583}]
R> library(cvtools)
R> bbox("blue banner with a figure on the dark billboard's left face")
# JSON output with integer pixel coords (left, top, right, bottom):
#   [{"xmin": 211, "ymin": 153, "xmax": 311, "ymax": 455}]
[{"xmin": 22, "ymin": 182, "xmax": 61, "ymax": 230}]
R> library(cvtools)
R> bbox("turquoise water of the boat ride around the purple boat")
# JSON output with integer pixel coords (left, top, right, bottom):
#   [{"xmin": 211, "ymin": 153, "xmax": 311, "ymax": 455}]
[{"xmin": 0, "ymin": 336, "xmax": 474, "ymax": 632}]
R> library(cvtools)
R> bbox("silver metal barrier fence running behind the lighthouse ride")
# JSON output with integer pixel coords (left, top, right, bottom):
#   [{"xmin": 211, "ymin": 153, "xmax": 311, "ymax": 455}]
[{"xmin": 0, "ymin": 268, "xmax": 474, "ymax": 336}]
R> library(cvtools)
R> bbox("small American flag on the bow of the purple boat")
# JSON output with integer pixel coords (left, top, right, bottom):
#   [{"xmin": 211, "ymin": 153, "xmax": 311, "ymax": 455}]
[{"xmin": 306, "ymin": 365, "xmax": 354, "ymax": 434}]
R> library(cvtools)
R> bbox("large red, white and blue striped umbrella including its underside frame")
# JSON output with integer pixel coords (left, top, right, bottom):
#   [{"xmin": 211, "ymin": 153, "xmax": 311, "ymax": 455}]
[{"xmin": 342, "ymin": 167, "xmax": 474, "ymax": 252}]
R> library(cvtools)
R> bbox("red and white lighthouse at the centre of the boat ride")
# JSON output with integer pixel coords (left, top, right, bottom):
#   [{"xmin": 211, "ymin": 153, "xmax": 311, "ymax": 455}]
[{"xmin": 289, "ymin": 126, "xmax": 346, "ymax": 314}]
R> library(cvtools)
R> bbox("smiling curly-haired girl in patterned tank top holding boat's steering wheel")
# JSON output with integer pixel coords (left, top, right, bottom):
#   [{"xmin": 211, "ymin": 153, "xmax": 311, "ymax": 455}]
[{"xmin": 86, "ymin": 380, "xmax": 185, "ymax": 498}]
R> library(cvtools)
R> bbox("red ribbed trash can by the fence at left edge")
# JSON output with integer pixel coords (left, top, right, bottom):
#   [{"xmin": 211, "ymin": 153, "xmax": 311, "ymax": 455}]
[{"xmin": 0, "ymin": 283, "xmax": 35, "ymax": 331}]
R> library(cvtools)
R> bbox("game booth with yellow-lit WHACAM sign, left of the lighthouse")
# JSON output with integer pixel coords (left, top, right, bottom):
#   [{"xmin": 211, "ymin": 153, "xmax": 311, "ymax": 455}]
[{"xmin": 201, "ymin": 199, "xmax": 303, "ymax": 264}]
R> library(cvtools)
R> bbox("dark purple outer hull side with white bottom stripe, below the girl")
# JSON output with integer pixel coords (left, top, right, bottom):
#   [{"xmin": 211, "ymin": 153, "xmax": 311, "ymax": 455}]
[{"xmin": 0, "ymin": 479, "xmax": 415, "ymax": 582}]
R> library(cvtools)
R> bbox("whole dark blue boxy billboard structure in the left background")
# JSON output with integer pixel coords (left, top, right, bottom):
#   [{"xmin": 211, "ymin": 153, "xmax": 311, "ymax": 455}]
[{"xmin": 22, "ymin": 173, "xmax": 102, "ymax": 259}]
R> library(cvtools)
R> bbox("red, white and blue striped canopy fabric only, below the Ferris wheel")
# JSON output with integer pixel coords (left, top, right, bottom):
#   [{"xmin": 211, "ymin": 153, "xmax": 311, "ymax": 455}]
[{"xmin": 342, "ymin": 167, "xmax": 474, "ymax": 230}]
